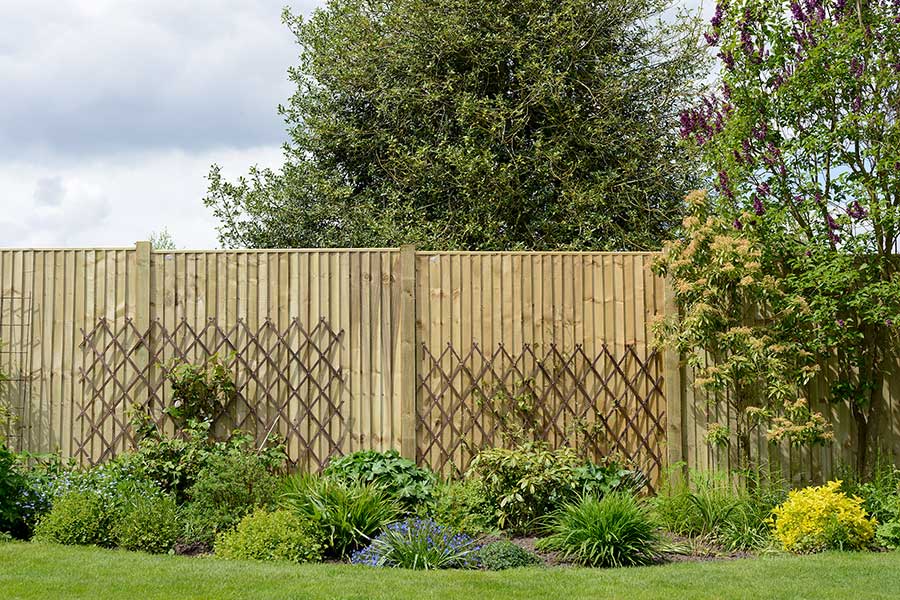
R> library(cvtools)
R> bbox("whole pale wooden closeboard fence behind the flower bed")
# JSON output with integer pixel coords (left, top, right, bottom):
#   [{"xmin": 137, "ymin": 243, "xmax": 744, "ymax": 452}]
[{"xmin": 0, "ymin": 242, "xmax": 900, "ymax": 482}]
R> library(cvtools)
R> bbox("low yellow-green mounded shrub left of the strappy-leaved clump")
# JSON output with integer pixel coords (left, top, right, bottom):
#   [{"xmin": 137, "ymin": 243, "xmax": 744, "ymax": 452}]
[{"xmin": 215, "ymin": 509, "xmax": 322, "ymax": 563}]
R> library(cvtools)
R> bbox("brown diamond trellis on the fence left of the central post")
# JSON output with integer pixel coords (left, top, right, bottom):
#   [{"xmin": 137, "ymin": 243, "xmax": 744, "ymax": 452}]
[{"xmin": 74, "ymin": 318, "xmax": 347, "ymax": 470}]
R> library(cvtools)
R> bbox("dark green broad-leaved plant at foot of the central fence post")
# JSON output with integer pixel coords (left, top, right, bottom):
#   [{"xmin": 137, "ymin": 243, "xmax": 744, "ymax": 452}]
[{"xmin": 322, "ymin": 450, "xmax": 437, "ymax": 509}]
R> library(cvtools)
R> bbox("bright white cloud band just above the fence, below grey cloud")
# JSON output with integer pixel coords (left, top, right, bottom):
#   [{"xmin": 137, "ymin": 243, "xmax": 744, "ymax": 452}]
[{"xmin": 0, "ymin": 146, "xmax": 281, "ymax": 248}]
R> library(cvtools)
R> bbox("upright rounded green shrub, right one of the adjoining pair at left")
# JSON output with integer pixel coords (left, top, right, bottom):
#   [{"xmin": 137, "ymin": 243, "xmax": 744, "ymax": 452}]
[{"xmin": 112, "ymin": 482, "xmax": 181, "ymax": 554}]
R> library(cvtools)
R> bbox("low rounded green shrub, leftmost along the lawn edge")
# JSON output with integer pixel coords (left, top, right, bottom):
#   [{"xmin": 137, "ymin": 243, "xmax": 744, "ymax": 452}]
[{"xmin": 34, "ymin": 490, "xmax": 115, "ymax": 547}]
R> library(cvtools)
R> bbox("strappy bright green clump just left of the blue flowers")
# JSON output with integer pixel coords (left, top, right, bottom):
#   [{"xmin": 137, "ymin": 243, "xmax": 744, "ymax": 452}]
[{"xmin": 280, "ymin": 475, "xmax": 401, "ymax": 558}]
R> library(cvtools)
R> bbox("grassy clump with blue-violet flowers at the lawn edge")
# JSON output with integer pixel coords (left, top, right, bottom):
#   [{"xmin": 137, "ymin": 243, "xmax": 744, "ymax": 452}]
[{"xmin": 350, "ymin": 519, "xmax": 480, "ymax": 569}]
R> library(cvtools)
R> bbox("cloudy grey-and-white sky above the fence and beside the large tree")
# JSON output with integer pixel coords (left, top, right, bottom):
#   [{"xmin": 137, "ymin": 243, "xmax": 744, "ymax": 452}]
[{"xmin": 0, "ymin": 0, "xmax": 708, "ymax": 248}]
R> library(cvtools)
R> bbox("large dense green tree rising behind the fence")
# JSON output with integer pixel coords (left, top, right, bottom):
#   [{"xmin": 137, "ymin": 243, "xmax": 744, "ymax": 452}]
[{"xmin": 206, "ymin": 0, "xmax": 705, "ymax": 250}]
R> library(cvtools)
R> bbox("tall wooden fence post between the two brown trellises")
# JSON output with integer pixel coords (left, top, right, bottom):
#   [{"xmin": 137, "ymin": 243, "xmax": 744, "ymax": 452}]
[{"xmin": 394, "ymin": 245, "xmax": 418, "ymax": 460}]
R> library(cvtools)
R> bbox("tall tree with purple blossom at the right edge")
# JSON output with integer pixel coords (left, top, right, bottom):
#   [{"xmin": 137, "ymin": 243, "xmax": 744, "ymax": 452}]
[{"xmin": 681, "ymin": 0, "xmax": 900, "ymax": 476}]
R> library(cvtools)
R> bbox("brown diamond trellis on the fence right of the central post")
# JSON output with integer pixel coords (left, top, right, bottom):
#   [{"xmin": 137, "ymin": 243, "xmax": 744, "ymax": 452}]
[{"xmin": 417, "ymin": 343, "xmax": 666, "ymax": 485}]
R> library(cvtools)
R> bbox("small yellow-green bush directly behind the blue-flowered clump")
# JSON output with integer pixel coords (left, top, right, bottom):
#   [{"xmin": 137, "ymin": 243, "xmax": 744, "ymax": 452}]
[{"xmin": 431, "ymin": 479, "xmax": 495, "ymax": 535}]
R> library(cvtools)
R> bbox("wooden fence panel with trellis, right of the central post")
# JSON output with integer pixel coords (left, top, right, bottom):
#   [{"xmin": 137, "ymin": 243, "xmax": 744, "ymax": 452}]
[{"xmin": 416, "ymin": 252, "xmax": 665, "ymax": 480}]
